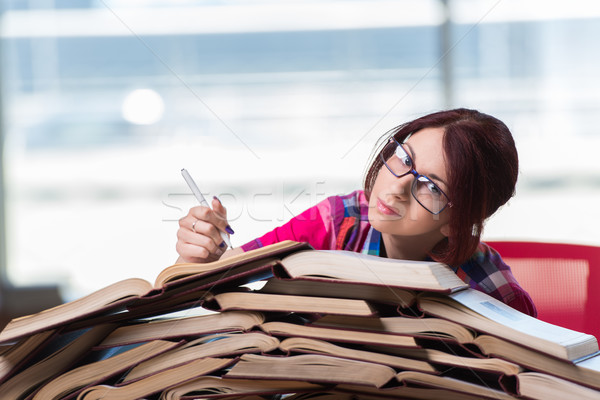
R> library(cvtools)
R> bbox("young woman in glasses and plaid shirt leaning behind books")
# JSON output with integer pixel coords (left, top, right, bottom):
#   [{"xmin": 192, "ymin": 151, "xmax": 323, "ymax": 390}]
[{"xmin": 177, "ymin": 109, "xmax": 536, "ymax": 316}]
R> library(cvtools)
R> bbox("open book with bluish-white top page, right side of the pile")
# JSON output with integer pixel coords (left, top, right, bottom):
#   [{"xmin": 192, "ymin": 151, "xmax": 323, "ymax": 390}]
[{"xmin": 418, "ymin": 289, "xmax": 598, "ymax": 361}]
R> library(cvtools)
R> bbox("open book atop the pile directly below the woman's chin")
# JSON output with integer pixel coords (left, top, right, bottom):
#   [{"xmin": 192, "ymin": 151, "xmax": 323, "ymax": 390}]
[{"xmin": 275, "ymin": 250, "xmax": 468, "ymax": 293}]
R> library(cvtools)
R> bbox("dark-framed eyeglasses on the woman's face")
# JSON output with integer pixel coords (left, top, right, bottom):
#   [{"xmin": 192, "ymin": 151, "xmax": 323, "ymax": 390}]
[{"xmin": 381, "ymin": 138, "xmax": 452, "ymax": 215}]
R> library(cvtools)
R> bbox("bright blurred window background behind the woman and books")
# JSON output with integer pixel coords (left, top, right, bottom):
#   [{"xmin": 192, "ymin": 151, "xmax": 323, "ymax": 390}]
[{"xmin": 0, "ymin": 0, "xmax": 600, "ymax": 314}]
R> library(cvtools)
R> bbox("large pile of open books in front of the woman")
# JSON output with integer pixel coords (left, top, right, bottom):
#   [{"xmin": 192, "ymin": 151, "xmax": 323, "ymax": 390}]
[{"xmin": 0, "ymin": 242, "xmax": 600, "ymax": 400}]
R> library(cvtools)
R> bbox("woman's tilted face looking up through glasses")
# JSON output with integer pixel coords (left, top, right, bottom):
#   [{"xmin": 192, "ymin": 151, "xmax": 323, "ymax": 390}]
[{"xmin": 369, "ymin": 128, "xmax": 449, "ymax": 242}]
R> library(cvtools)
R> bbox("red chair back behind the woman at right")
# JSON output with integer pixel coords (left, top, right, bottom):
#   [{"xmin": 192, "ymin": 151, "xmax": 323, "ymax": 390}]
[{"xmin": 486, "ymin": 241, "xmax": 600, "ymax": 339}]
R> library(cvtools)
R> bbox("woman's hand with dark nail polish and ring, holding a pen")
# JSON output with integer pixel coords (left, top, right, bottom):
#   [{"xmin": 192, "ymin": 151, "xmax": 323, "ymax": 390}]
[{"xmin": 176, "ymin": 197, "xmax": 233, "ymax": 263}]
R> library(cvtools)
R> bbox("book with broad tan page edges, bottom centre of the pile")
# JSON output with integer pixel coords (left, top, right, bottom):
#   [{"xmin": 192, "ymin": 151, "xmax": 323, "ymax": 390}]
[{"xmin": 224, "ymin": 354, "xmax": 396, "ymax": 387}]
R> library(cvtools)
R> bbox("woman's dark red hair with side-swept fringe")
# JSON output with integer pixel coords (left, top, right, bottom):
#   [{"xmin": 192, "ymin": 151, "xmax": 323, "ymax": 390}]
[{"xmin": 364, "ymin": 108, "xmax": 519, "ymax": 266}]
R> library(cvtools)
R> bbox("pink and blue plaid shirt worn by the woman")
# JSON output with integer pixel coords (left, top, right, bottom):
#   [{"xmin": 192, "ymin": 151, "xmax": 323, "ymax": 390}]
[{"xmin": 242, "ymin": 190, "xmax": 537, "ymax": 317}]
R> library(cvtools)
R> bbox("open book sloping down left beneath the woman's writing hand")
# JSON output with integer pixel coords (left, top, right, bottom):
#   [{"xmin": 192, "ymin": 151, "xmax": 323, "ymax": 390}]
[{"xmin": 0, "ymin": 241, "xmax": 310, "ymax": 343}]
